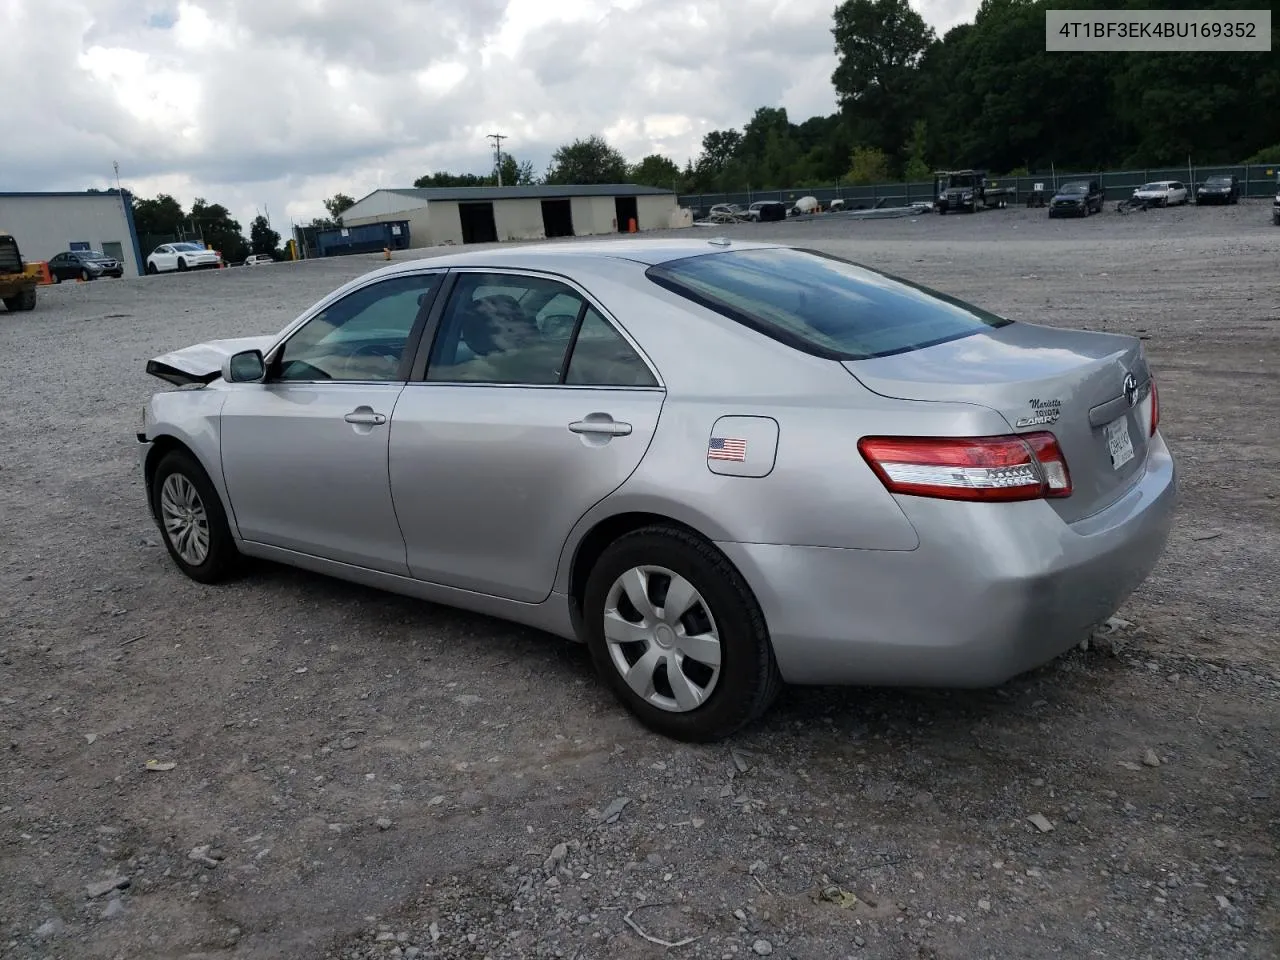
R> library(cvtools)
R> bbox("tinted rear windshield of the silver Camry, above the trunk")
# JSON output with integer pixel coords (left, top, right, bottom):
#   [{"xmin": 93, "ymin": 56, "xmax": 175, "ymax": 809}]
[{"xmin": 645, "ymin": 247, "xmax": 1012, "ymax": 360}]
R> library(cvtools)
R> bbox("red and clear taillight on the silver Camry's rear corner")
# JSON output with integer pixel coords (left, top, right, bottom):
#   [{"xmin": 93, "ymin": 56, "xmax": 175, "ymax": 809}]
[{"xmin": 858, "ymin": 433, "xmax": 1071, "ymax": 502}]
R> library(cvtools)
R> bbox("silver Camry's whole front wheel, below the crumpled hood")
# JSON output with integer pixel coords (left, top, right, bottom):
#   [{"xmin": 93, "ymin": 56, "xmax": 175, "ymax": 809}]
[{"xmin": 151, "ymin": 451, "xmax": 239, "ymax": 584}]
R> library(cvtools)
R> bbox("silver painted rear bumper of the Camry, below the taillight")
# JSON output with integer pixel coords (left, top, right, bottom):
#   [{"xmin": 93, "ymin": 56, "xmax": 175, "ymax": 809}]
[{"xmin": 719, "ymin": 435, "xmax": 1176, "ymax": 687}]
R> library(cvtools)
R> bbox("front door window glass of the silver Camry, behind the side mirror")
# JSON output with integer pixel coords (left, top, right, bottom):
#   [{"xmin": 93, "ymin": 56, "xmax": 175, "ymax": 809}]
[{"xmin": 270, "ymin": 274, "xmax": 442, "ymax": 380}]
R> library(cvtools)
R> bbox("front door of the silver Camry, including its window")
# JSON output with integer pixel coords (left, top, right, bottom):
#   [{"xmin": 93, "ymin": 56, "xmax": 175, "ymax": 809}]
[{"xmin": 221, "ymin": 270, "xmax": 444, "ymax": 575}]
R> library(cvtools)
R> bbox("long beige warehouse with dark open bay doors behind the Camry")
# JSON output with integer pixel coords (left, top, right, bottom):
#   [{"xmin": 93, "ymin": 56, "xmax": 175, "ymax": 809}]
[{"xmin": 342, "ymin": 183, "xmax": 682, "ymax": 247}]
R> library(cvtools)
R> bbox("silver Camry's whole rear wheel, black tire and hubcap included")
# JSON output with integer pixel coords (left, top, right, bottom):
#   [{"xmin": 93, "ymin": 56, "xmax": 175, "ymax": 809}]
[{"xmin": 582, "ymin": 526, "xmax": 782, "ymax": 742}]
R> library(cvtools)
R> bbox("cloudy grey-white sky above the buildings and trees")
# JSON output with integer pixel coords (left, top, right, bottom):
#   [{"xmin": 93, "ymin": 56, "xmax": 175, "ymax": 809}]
[{"xmin": 0, "ymin": 0, "xmax": 977, "ymax": 233}]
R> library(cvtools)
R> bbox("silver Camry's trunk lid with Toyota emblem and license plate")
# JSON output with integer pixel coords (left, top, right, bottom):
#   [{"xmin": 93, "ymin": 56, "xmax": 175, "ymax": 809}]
[{"xmin": 844, "ymin": 323, "xmax": 1151, "ymax": 522}]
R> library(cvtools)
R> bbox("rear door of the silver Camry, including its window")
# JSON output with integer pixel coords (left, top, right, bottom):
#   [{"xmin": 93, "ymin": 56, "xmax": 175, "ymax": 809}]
[{"xmin": 390, "ymin": 270, "xmax": 664, "ymax": 603}]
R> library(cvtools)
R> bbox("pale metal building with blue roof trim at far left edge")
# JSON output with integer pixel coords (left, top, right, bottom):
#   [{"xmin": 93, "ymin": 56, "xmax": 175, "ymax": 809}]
[{"xmin": 0, "ymin": 189, "xmax": 143, "ymax": 276}]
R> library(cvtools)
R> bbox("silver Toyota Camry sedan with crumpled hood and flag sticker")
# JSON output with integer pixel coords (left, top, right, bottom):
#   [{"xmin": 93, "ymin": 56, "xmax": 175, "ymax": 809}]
[{"xmin": 138, "ymin": 238, "xmax": 1176, "ymax": 740}]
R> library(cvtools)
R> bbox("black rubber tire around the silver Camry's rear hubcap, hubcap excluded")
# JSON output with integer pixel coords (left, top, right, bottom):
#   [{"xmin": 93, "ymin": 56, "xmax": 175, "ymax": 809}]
[{"xmin": 582, "ymin": 526, "xmax": 782, "ymax": 742}]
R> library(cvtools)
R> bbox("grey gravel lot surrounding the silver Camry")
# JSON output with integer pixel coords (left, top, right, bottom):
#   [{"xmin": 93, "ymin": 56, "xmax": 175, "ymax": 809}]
[{"xmin": 0, "ymin": 202, "xmax": 1280, "ymax": 960}]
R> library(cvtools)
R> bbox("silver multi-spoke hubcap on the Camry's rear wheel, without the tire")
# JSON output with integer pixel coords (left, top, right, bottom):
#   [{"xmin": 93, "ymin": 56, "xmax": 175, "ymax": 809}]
[{"xmin": 604, "ymin": 566, "xmax": 721, "ymax": 713}]
